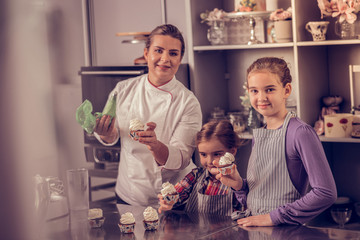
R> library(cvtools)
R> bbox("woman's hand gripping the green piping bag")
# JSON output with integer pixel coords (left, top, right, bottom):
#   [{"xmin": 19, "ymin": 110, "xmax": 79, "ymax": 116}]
[{"xmin": 94, "ymin": 115, "xmax": 118, "ymax": 143}]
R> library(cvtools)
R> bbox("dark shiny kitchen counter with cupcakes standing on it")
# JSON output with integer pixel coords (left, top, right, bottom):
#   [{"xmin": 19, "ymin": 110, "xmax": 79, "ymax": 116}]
[{"xmin": 40, "ymin": 203, "xmax": 360, "ymax": 240}]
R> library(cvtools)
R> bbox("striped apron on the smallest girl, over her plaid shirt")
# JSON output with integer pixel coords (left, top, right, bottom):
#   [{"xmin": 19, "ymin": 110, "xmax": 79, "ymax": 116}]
[{"xmin": 185, "ymin": 170, "xmax": 233, "ymax": 216}]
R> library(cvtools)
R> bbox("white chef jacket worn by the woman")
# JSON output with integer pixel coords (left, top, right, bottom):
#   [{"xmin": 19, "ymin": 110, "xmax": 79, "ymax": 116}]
[{"xmin": 95, "ymin": 74, "xmax": 202, "ymax": 206}]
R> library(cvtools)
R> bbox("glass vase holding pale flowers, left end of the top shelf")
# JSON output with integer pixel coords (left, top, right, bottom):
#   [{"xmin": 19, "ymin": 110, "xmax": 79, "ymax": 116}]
[{"xmin": 207, "ymin": 20, "xmax": 227, "ymax": 45}]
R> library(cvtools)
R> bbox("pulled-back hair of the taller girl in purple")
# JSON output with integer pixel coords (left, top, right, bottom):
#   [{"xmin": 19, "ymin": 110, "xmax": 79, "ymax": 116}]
[{"xmin": 247, "ymin": 57, "xmax": 292, "ymax": 87}]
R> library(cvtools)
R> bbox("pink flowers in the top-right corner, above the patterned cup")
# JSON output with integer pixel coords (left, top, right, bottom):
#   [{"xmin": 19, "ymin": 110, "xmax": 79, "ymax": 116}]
[{"xmin": 317, "ymin": 0, "xmax": 360, "ymax": 24}]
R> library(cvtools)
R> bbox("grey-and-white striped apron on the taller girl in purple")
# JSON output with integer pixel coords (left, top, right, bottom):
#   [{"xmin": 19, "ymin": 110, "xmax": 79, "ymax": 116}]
[{"xmin": 247, "ymin": 112, "xmax": 301, "ymax": 215}]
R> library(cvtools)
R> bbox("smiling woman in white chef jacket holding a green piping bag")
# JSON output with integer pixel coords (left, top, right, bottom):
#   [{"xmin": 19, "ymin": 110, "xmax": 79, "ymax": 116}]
[{"xmin": 95, "ymin": 24, "xmax": 202, "ymax": 206}]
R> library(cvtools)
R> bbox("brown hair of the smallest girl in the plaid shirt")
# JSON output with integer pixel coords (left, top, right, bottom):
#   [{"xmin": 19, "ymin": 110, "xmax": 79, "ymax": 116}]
[{"xmin": 195, "ymin": 120, "xmax": 243, "ymax": 149}]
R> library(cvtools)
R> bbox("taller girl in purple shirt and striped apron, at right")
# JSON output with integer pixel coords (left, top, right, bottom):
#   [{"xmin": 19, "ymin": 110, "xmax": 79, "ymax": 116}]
[{"xmin": 213, "ymin": 57, "xmax": 337, "ymax": 226}]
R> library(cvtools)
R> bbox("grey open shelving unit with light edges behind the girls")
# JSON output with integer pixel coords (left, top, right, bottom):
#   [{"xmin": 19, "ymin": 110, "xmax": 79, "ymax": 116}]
[{"xmin": 185, "ymin": 0, "xmax": 360, "ymax": 201}]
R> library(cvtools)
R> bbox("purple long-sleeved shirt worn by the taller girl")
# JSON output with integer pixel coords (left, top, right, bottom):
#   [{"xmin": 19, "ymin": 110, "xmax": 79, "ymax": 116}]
[{"xmin": 235, "ymin": 118, "xmax": 337, "ymax": 225}]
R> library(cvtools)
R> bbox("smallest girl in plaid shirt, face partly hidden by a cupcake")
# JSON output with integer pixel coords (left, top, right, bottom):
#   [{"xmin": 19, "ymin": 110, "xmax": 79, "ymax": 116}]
[{"xmin": 158, "ymin": 120, "xmax": 245, "ymax": 216}]
